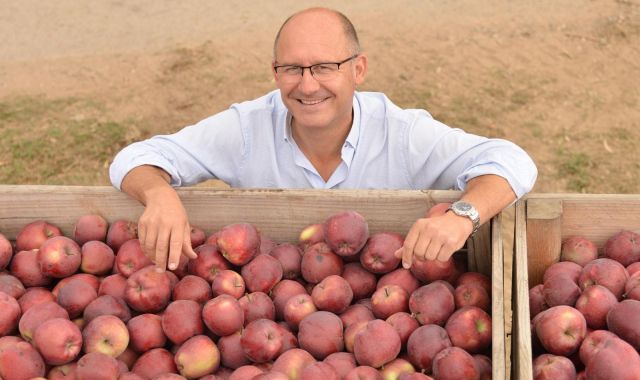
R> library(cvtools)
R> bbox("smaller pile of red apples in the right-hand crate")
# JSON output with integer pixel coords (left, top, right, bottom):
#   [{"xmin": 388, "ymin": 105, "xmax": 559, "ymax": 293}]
[{"xmin": 529, "ymin": 230, "xmax": 640, "ymax": 380}]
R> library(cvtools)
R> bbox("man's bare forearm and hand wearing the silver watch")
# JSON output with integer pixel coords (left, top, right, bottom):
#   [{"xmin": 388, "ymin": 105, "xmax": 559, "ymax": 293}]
[{"xmin": 396, "ymin": 175, "xmax": 516, "ymax": 268}]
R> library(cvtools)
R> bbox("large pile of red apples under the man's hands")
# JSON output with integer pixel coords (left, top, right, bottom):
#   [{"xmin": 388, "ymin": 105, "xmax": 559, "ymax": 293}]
[{"xmin": 0, "ymin": 207, "xmax": 491, "ymax": 380}]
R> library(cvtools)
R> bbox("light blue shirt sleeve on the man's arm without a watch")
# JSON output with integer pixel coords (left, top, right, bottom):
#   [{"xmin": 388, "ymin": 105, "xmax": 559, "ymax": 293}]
[{"xmin": 109, "ymin": 108, "xmax": 248, "ymax": 189}]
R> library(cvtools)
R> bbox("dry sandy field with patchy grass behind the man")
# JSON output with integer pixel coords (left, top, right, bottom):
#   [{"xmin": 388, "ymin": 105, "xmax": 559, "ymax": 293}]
[{"xmin": 0, "ymin": 0, "xmax": 640, "ymax": 193}]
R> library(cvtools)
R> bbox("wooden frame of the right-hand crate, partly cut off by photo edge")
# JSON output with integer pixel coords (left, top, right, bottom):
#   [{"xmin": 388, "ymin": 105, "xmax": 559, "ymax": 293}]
[{"xmin": 511, "ymin": 194, "xmax": 640, "ymax": 380}]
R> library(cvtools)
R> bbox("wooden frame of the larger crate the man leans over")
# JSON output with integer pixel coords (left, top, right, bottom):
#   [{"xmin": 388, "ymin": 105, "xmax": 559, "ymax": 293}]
[{"xmin": 0, "ymin": 185, "xmax": 508, "ymax": 379}]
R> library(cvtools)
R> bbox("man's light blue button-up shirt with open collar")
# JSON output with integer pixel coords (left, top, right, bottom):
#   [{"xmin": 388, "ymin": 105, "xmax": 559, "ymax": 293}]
[{"xmin": 109, "ymin": 90, "xmax": 537, "ymax": 197}]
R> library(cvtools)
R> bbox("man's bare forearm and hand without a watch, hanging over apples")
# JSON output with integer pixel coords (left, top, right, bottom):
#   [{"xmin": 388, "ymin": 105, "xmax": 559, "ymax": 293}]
[{"xmin": 121, "ymin": 165, "xmax": 197, "ymax": 270}]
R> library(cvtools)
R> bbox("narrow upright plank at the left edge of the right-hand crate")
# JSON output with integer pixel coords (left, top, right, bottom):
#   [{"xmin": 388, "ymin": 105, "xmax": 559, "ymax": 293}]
[{"xmin": 511, "ymin": 200, "xmax": 533, "ymax": 380}]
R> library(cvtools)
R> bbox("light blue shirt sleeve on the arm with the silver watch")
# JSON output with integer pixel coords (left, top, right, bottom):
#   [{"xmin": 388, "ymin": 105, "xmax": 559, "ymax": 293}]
[{"xmin": 407, "ymin": 113, "xmax": 538, "ymax": 198}]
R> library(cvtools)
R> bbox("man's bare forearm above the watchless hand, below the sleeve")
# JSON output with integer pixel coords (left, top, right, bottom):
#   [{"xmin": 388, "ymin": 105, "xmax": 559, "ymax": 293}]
[{"xmin": 121, "ymin": 165, "xmax": 174, "ymax": 206}]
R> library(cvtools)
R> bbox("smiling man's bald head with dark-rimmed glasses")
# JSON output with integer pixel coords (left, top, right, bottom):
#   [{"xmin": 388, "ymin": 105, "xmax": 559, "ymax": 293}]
[{"xmin": 273, "ymin": 8, "xmax": 367, "ymax": 134}]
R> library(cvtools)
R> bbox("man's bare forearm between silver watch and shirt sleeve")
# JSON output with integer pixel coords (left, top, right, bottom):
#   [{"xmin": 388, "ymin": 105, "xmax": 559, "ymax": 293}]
[{"xmin": 461, "ymin": 174, "xmax": 516, "ymax": 224}]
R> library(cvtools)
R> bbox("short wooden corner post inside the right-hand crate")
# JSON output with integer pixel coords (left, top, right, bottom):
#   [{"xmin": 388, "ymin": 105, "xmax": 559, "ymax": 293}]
[{"xmin": 526, "ymin": 199, "xmax": 562, "ymax": 287}]
